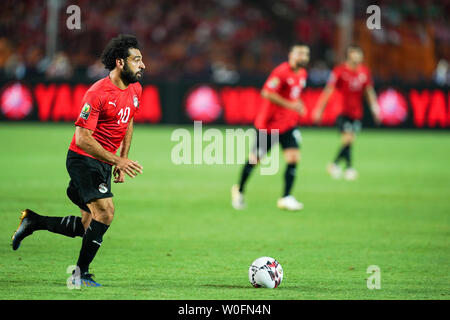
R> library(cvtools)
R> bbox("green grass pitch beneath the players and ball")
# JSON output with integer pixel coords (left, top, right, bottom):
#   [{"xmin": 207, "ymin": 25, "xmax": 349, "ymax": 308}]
[{"xmin": 0, "ymin": 123, "xmax": 450, "ymax": 300}]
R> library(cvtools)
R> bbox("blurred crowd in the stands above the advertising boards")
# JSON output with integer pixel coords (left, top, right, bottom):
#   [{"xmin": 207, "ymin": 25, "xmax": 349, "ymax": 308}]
[{"xmin": 0, "ymin": 0, "xmax": 450, "ymax": 85}]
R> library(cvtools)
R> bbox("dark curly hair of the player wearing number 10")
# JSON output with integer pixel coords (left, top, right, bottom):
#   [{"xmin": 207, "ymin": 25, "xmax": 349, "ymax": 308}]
[{"xmin": 101, "ymin": 34, "xmax": 139, "ymax": 70}]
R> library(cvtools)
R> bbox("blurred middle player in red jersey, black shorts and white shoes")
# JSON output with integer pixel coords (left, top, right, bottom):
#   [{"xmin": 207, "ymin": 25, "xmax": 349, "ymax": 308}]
[{"xmin": 231, "ymin": 45, "xmax": 309, "ymax": 210}]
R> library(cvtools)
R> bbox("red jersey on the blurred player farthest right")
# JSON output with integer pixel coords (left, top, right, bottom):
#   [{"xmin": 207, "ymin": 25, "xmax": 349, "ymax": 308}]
[{"xmin": 328, "ymin": 63, "xmax": 372, "ymax": 119}]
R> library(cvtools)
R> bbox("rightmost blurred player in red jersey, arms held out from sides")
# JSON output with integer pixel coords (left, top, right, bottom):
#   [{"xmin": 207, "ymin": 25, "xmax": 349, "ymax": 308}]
[{"xmin": 314, "ymin": 46, "xmax": 380, "ymax": 180}]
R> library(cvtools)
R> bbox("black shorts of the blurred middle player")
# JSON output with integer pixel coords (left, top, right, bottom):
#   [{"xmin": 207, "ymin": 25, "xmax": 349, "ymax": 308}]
[{"xmin": 252, "ymin": 127, "xmax": 302, "ymax": 159}]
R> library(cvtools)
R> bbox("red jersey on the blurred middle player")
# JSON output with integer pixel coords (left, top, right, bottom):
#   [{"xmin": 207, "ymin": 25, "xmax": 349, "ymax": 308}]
[{"xmin": 254, "ymin": 62, "xmax": 308, "ymax": 134}]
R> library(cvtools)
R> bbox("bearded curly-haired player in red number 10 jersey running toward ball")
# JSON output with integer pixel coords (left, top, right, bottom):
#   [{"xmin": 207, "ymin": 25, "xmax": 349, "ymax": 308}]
[{"xmin": 12, "ymin": 35, "xmax": 145, "ymax": 286}]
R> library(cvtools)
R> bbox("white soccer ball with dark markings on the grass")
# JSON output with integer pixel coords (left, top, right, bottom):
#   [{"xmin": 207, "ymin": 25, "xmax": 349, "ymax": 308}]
[{"xmin": 248, "ymin": 257, "xmax": 283, "ymax": 289}]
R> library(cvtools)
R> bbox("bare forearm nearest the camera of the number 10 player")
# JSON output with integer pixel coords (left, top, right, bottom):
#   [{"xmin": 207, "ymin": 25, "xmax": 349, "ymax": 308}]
[{"xmin": 75, "ymin": 126, "xmax": 119, "ymax": 164}]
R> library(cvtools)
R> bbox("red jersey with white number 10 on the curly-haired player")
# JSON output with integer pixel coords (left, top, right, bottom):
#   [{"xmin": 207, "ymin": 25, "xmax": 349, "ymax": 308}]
[{"xmin": 69, "ymin": 76, "xmax": 142, "ymax": 162}]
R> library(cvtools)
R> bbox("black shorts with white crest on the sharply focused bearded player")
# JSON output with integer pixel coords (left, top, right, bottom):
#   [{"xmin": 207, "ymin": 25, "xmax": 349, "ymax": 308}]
[{"xmin": 66, "ymin": 150, "xmax": 113, "ymax": 212}]
